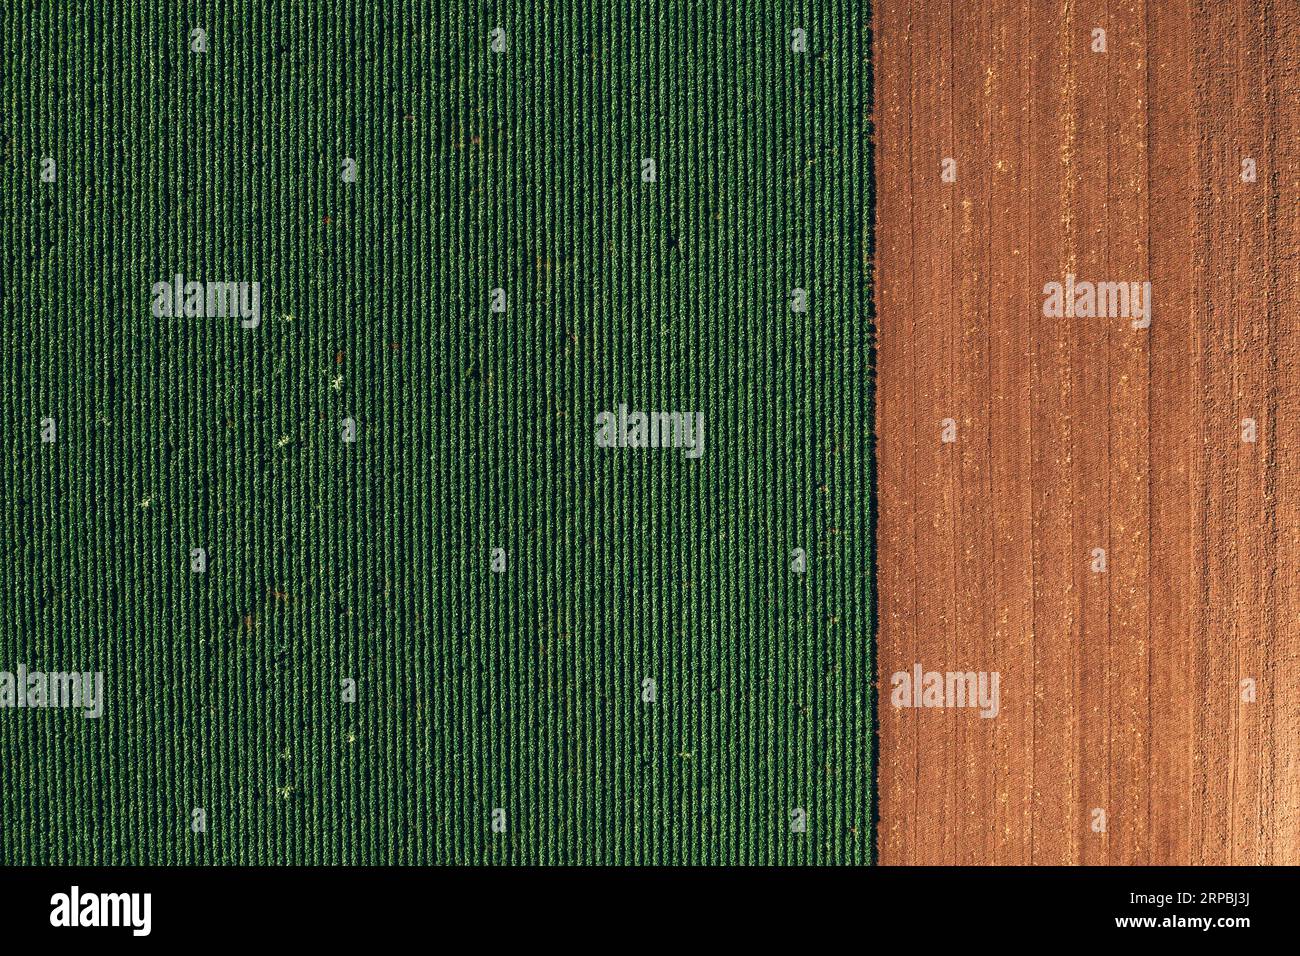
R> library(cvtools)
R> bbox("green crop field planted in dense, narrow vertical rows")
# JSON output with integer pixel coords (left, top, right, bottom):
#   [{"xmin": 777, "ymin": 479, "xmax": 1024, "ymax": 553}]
[{"xmin": 0, "ymin": 0, "xmax": 874, "ymax": 864}]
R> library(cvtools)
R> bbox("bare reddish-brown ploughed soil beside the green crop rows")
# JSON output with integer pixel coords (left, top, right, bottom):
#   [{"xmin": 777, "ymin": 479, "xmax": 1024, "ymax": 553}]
[{"xmin": 874, "ymin": 0, "xmax": 1300, "ymax": 864}]
